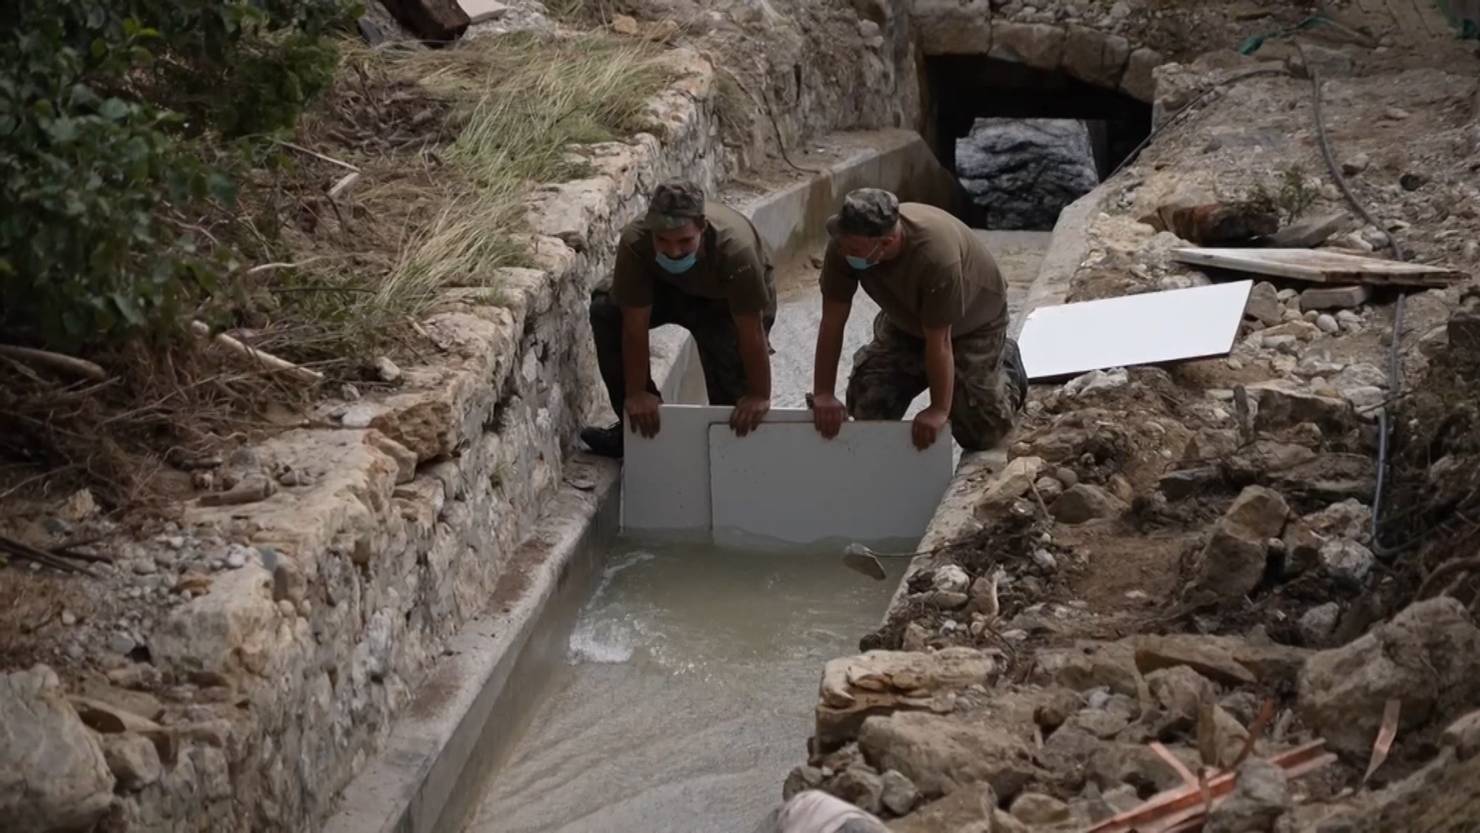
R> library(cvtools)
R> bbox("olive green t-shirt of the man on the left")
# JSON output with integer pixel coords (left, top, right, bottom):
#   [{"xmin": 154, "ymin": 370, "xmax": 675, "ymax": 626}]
[{"xmin": 611, "ymin": 201, "xmax": 776, "ymax": 315}]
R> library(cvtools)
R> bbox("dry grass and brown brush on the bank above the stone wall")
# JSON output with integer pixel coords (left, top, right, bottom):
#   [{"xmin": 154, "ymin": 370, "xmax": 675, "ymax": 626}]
[{"xmin": 0, "ymin": 33, "xmax": 669, "ymax": 509}]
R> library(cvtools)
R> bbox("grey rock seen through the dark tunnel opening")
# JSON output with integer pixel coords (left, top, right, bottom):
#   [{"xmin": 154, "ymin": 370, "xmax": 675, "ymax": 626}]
[{"xmin": 956, "ymin": 118, "xmax": 1100, "ymax": 228}]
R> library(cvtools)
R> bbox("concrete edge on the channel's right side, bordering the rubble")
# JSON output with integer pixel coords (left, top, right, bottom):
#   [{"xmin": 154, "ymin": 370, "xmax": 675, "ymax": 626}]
[{"xmin": 882, "ymin": 182, "xmax": 1110, "ymax": 623}]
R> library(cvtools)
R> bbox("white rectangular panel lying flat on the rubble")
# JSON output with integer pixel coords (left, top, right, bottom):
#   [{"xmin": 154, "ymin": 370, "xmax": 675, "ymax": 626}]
[{"xmin": 1018, "ymin": 281, "xmax": 1254, "ymax": 379}]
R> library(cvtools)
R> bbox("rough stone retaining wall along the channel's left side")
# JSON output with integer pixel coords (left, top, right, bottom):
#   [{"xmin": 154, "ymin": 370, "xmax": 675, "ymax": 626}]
[{"xmin": 0, "ymin": 50, "xmax": 728, "ymax": 833}]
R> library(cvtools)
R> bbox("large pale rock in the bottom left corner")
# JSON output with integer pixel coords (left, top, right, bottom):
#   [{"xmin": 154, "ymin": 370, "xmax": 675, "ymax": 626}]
[{"xmin": 0, "ymin": 666, "xmax": 114, "ymax": 830}]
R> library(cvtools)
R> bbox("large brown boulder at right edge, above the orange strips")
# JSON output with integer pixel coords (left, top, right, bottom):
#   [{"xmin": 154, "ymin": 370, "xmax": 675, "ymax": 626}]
[{"xmin": 1298, "ymin": 596, "xmax": 1480, "ymax": 761}]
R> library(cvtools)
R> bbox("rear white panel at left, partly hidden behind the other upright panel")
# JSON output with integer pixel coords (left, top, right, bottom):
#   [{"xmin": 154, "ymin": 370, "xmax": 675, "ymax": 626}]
[{"xmin": 622, "ymin": 405, "xmax": 813, "ymax": 533}]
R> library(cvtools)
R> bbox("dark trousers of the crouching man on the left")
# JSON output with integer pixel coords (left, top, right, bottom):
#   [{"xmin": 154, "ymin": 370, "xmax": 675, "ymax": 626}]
[{"xmin": 591, "ymin": 281, "xmax": 776, "ymax": 419}]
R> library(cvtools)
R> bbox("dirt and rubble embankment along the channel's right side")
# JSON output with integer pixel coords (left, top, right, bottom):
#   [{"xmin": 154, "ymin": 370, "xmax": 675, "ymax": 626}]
[{"xmin": 787, "ymin": 3, "xmax": 1480, "ymax": 833}]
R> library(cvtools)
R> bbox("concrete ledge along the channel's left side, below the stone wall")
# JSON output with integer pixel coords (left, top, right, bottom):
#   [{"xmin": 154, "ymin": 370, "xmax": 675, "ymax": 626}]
[{"xmin": 323, "ymin": 130, "xmax": 963, "ymax": 833}]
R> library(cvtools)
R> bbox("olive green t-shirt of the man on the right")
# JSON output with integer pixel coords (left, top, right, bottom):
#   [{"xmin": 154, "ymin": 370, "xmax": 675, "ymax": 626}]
[{"xmin": 821, "ymin": 203, "xmax": 1008, "ymax": 337}]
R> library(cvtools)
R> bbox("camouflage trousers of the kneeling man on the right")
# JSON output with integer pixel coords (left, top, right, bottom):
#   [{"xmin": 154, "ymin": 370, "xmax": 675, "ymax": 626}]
[{"xmin": 847, "ymin": 312, "xmax": 1027, "ymax": 451}]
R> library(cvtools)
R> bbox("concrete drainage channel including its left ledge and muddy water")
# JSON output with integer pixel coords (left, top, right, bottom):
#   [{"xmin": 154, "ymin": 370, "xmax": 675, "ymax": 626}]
[{"xmin": 326, "ymin": 132, "xmax": 1071, "ymax": 833}]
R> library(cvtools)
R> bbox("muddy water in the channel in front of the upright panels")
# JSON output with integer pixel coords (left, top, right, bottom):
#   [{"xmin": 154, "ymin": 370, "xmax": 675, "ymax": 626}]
[{"xmin": 466, "ymin": 542, "xmax": 898, "ymax": 833}]
